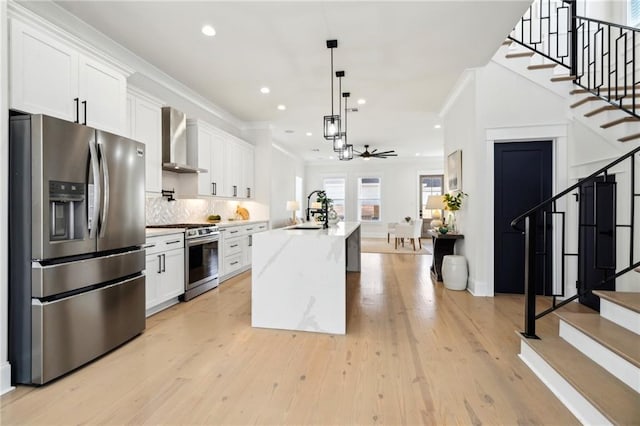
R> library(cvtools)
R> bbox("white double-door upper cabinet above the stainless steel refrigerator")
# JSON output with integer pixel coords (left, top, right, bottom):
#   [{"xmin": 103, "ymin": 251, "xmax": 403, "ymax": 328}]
[{"xmin": 9, "ymin": 19, "xmax": 127, "ymax": 134}]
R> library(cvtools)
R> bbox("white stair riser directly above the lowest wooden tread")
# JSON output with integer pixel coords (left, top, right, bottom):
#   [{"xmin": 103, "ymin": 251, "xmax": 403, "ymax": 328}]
[{"xmin": 560, "ymin": 320, "xmax": 640, "ymax": 393}]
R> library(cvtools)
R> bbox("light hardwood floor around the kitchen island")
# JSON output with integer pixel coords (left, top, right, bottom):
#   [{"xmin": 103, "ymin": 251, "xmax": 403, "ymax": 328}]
[{"xmin": 0, "ymin": 253, "xmax": 578, "ymax": 425}]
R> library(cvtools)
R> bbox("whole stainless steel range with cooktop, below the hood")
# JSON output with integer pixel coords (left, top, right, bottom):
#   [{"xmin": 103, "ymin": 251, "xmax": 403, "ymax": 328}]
[{"xmin": 150, "ymin": 223, "xmax": 220, "ymax": 301}]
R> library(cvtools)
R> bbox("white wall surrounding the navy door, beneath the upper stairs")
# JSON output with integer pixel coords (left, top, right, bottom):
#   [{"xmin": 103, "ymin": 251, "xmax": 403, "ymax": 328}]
[{"xmin": 443, "ymin": 50, "xmax": 637, "ymax": 295}]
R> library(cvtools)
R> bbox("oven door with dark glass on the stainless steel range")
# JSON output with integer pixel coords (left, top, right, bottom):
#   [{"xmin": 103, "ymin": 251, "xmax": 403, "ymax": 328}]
[{"xmin": 185, "ymin": 235, "xmax": 219, "ymax": 291}]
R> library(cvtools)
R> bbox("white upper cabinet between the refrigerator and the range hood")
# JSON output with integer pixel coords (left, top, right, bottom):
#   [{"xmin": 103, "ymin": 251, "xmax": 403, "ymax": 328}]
[{"xmin": 126, "ymin": 88, "xmax": 162, "ymax": 192}]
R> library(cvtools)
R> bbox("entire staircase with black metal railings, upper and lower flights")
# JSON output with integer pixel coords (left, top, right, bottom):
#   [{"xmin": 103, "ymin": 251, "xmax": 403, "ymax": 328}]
[{"xmin": 497, "ymin": 0, "xmax": 640, "ymax": 425}]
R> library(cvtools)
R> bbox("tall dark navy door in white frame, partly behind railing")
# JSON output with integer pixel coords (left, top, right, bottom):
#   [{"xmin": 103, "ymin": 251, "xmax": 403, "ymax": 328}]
[{"xmin": 494, "ymin": 141, "xmax": 553, "ymax": 294}]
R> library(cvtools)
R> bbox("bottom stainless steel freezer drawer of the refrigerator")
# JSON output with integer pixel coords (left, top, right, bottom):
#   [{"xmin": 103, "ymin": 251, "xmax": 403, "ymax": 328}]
[{"xmin": 31, "ymin": 275, "xmax": 145, "ymax": 384}]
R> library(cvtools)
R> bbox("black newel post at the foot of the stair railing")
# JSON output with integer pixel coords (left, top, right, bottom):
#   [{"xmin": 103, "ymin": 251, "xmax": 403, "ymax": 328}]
[{"xmin": 523, "ymin": 212, "xmax": 538, "ymax": 339}]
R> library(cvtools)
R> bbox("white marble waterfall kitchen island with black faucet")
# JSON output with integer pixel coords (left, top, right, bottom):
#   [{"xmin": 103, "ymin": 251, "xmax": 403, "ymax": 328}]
[{"xmin": 251, "ymin": 222, "xmax": 360, "ymax": 334}]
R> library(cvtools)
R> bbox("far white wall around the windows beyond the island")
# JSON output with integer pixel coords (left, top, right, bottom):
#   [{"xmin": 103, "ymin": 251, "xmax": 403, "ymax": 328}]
[{"xmin": 303, "ymin": 157, "xmax": 443, "ymax": 237}]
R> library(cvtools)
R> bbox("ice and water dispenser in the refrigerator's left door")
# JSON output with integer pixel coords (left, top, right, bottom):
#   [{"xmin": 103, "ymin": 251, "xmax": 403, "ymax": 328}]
[{"xmin": 49, "ymin": 181, "xmax": 87, "ymax": 241}]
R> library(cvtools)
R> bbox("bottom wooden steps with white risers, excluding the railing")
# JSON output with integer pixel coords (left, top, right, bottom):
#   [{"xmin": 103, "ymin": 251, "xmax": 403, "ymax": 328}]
[{"xmin": 520, "ymin": 291, "xmax": 640, "ymax": 425}]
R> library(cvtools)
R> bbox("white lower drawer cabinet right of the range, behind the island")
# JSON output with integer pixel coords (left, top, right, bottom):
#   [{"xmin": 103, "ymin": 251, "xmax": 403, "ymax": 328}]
[{"xmin": 219, "ymin": 222, "xmax": 269, "ymax": 282}]
